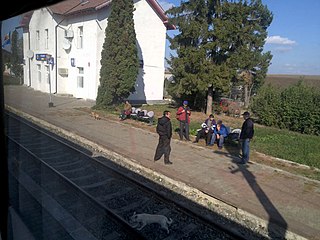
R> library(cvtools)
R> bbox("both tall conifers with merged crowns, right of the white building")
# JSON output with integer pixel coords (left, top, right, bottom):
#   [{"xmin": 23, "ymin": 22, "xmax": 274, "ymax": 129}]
[{"xmin": 168, "ymin": 0, "xmax": 272, "ymax": 113}]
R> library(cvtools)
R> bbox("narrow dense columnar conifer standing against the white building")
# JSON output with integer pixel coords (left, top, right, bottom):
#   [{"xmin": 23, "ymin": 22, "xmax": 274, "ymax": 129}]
[{"xmin": 96, "ymin": 0, "xmax": 139, "ymax": 108}]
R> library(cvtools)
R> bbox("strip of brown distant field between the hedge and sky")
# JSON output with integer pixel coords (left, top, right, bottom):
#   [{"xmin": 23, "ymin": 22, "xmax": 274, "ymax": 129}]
[{"xmin": 265, "ymin": 74, "xmax": 320, "ymax": 88}]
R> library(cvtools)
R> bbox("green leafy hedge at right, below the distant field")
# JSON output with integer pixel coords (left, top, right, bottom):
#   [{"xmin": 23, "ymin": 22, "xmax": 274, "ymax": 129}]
[{"xmin": 251, "ymin": 81, "xmax": 320, "ymax": 135}]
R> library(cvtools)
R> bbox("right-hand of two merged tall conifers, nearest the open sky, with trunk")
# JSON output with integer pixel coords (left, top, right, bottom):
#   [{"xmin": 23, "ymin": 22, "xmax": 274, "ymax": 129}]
[{"xmin": 214, "ymin": 0, "xmax": 273, "ymax": 107}]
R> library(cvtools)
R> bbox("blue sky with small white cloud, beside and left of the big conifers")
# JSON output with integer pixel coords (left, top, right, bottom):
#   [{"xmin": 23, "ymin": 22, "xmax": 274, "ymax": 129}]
[{"xmin": 158, "ymin": 0, "xmax": 320, "ymax": 75}]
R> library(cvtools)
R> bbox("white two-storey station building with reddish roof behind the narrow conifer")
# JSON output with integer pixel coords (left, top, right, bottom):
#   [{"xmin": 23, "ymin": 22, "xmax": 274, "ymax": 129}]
[{"xmin": 21, "ymin": 0, "xmax": 174, "ymax": 103}]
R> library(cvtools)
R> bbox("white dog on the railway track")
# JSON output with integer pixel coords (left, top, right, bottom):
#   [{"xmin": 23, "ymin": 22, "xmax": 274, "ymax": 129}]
[{"xmin": 130, "ymin": 212, "xmax": 173, "ymax": 234}]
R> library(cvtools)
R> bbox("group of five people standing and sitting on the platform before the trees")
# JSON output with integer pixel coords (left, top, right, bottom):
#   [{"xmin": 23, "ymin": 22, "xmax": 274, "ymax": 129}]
[{"xmin": 154, "ymin": 101, "xmax": 254, "ymax": 164}]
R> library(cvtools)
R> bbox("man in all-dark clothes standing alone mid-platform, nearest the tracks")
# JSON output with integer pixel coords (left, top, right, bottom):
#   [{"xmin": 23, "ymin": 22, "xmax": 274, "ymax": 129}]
[{"xmin": 154, "ymin": 111, "xmax": 172, "ymax": 164}]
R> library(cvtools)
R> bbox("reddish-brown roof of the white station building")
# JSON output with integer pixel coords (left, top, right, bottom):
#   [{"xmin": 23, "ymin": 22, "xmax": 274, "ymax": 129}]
[{"xmin": 20, "ymin": 0, "xmax": 175, "ymax": 30}]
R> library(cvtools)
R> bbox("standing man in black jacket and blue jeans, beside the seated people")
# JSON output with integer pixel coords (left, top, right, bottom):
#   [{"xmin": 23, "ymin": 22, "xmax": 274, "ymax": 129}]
[{"xmin": 240, "ymin": 112, "xmax": 254, "ymax": 164}]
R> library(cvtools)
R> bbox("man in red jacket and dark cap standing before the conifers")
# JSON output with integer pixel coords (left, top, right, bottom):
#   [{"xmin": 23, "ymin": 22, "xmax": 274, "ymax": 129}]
[{"xmin": 177, "ymin": 101, "xmax": 191, "ymax": 141}]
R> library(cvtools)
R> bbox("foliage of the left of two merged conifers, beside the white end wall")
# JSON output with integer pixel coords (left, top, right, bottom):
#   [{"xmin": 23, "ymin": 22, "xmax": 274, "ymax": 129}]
[{"xmin": 167, "ymin": 0, "xmax": 224, "ymax": 111}]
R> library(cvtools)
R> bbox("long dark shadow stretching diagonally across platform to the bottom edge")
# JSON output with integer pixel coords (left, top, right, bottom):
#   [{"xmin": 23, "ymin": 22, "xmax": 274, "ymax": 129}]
[{"xmin": 230, "ymin": 160, "xmax": 288, "ymax": 239}]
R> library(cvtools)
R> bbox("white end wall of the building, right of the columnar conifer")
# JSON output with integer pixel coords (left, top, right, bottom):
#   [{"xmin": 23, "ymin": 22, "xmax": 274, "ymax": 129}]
[{"xmin": 130, "ymin": 0, "xmax": 166, "ymax": 102}]
